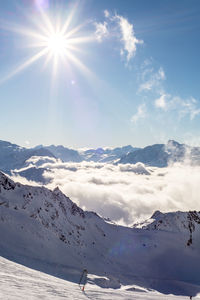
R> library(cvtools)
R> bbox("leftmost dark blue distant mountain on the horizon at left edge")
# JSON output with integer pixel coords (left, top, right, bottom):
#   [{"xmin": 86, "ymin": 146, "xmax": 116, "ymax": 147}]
[{"xmin": 0, "ymin": 141, "xmax": 54, "ymax": 173}]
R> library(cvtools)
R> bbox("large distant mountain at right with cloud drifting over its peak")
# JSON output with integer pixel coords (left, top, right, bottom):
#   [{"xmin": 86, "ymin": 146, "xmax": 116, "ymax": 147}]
[{"xmin": 119, "ymin": 140, "xmax": 200, "ymax": 167}]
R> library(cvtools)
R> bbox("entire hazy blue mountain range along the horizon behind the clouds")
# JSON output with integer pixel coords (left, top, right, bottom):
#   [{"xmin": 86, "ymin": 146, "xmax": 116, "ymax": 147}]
[{"xmin": 0, "ymin": 140, "xmax": 200, "ymax": 179}]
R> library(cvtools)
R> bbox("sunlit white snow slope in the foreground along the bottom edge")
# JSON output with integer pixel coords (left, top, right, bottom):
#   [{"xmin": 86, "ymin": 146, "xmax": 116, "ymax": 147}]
[{"xmin": 0, "ymin": 257, "xmax": 200, "ymax": 300}]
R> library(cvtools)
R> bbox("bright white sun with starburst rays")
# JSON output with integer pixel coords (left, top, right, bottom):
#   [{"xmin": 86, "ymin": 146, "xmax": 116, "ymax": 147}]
[{"xmin": 0, "ymin": 6, "xmax": 94, "ymax": 83}]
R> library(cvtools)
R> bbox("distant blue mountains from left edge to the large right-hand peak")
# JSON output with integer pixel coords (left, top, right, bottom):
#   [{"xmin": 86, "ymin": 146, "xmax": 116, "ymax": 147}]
[{"xmin": 0, "ymin": 141, "xmax": 138, "ymax": 173}]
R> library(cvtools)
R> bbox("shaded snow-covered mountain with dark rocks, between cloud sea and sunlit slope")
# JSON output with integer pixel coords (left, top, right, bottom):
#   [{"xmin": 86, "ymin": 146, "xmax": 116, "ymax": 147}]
[{"xmin": 0, "ymin": 173, "xmax": 200, "ymax": 295}]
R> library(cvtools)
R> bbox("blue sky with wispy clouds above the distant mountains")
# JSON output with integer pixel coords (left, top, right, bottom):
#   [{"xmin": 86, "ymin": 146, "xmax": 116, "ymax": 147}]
[{"xmin": 0, "ymin": 0, "xmax": 200, "ymax": 148}]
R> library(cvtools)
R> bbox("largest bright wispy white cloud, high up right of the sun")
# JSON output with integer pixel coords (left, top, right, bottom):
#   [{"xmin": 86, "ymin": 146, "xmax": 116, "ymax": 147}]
[{"xmin": 115, "ymin": 15, "xmax": 143, "ymax": 61}]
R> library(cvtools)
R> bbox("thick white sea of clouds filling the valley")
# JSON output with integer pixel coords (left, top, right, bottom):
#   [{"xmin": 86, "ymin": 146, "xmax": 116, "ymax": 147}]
[{"xmin": 11, "ymin": 157, "xmax": 200, "ymax": 226}]
